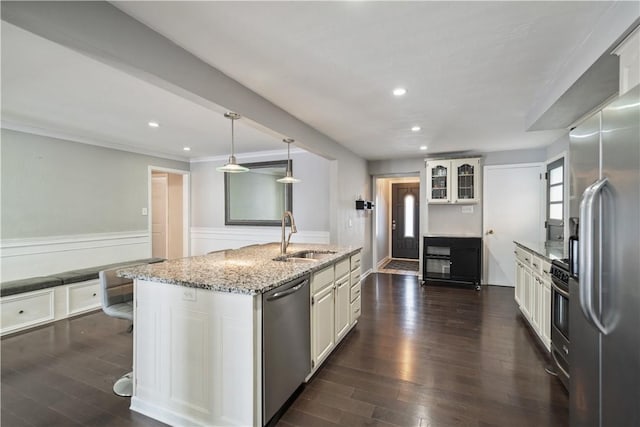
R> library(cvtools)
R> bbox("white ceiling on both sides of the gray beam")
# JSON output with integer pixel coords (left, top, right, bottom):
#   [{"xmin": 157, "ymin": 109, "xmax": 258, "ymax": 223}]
[{"xmin": 2, "ymin": 1, "xmax": 612, "ymax": 160}]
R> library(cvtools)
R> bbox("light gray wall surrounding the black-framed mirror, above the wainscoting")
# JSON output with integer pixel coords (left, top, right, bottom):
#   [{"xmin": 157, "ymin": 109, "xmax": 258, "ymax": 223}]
[{"xmin": 191, "ymin": 153, "xmax": 330, "ymax": 232}]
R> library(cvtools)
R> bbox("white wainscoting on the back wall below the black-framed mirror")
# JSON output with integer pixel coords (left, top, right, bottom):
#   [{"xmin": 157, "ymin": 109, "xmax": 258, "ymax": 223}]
[{"xmin": 191, "ymin": 227, "xmax": 329, "ymax": 255}]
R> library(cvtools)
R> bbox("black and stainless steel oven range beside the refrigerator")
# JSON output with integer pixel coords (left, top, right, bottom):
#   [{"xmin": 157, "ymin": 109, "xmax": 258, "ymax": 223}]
[{"xmin": 551, "ymin": 260, "xmax": 570, "ymax": 390}]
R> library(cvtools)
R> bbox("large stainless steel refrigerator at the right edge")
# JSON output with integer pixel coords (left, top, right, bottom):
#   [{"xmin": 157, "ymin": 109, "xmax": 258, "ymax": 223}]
[{"xmin": 569, "ymin": 86, "xmax": 640, "ymax": 427}]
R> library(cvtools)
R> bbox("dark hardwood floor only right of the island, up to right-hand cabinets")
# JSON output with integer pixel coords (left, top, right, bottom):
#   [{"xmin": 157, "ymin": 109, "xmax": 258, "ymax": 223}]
[{"xmin": 279, "ymin": 274, "xmax": 569, "ymax": 427}]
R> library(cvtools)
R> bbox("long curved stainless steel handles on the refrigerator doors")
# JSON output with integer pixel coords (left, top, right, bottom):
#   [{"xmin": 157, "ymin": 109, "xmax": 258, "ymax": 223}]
[{"xmin": 578, "ymin": 178, "xmax": 609, "ymax": 335}]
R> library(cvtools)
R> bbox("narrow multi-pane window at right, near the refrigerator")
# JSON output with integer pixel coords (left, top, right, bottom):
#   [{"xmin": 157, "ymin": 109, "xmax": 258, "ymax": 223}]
[{"xmin": 546, "ymin": 158, "xmax": 564, "ymax": 242}]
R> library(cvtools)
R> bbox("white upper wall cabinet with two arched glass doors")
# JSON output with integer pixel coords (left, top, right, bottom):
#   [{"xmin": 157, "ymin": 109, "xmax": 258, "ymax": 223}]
[{"xmin": 427, "ymin": 157, "xmax": 480, "ymax": 203}]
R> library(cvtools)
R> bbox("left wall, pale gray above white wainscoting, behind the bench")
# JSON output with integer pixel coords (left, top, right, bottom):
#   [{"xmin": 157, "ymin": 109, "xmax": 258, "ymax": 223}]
[{"xmin": 0, "ymin": 129, "xmax": 189, "ymax": 281}]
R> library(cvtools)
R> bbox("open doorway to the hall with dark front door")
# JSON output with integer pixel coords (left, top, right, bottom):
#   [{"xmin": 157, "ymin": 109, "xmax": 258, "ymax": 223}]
[{"xmin": 372, "ymin": 173, "xmax": 422, "ymax": 275}]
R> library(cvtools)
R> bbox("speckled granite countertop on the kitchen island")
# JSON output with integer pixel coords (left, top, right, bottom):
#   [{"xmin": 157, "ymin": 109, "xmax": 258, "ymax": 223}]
[{"xmin": 117, "ymin": 243, "xmax": 362, "ymax": 295}]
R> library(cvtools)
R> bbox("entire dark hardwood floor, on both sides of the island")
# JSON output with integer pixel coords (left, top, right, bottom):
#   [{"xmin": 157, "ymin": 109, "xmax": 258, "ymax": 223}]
[{"xmin": 1, "ymin": 274, "xmax": 568, "ymax": 427}]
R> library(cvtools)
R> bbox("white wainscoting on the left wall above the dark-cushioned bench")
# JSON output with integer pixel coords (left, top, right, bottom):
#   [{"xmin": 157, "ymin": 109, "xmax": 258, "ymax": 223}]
[{"xmin": 0, "ymin": 230, "xmax": 151, "ymax": 281}]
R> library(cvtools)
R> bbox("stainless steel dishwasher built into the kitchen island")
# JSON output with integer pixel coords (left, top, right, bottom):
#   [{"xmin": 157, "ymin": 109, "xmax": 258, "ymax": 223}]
[{"xmin": 262, "ymin": 276, "xmax": 311, "ymax": 425}]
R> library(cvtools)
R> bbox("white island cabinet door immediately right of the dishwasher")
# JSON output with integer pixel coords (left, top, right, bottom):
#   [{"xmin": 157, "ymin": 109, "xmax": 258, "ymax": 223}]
[{"xmin": 311, "ymin": 285, "xmax": 335, "ymax": 367}]
